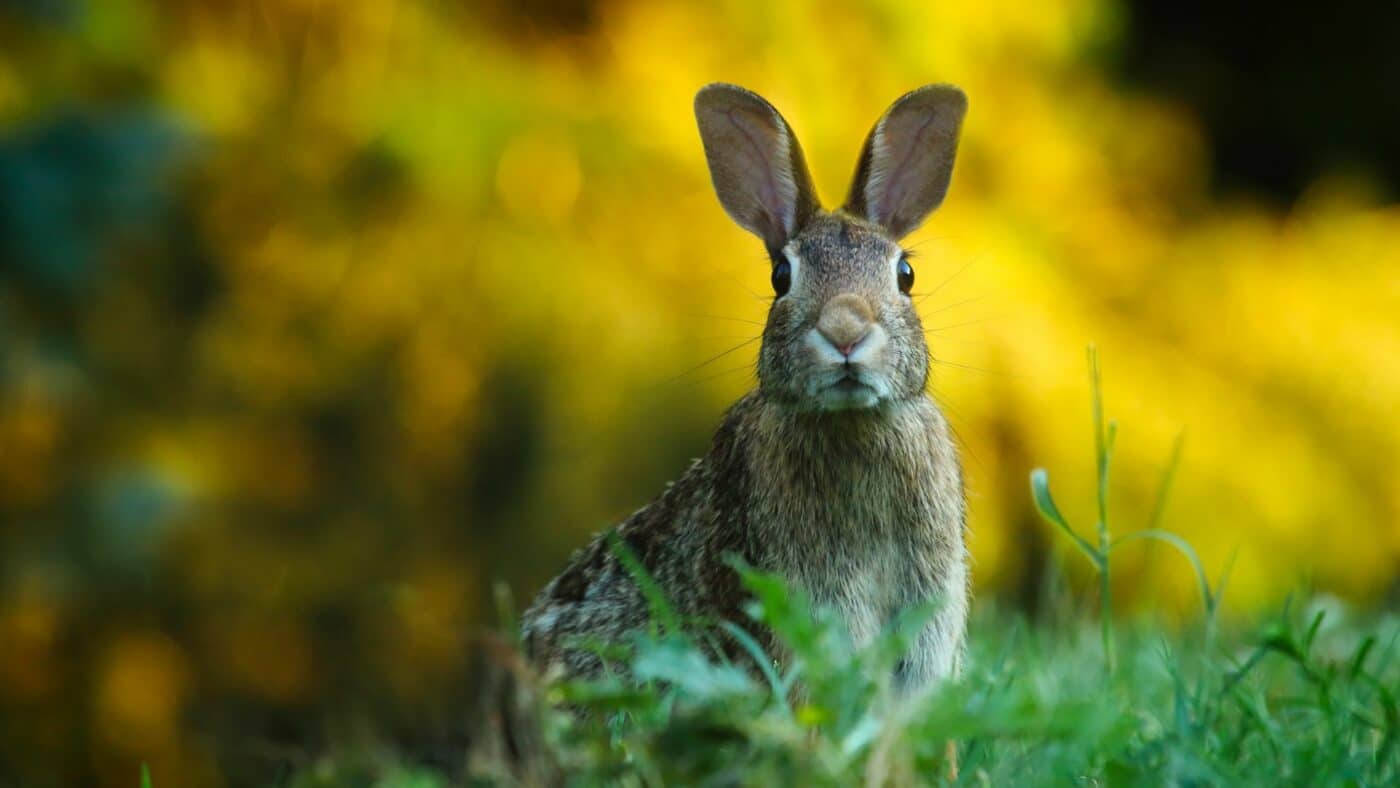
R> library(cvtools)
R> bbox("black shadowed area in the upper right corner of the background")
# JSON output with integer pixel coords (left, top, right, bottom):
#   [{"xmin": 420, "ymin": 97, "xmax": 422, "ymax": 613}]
[{"xmin": 1119, "ymin": 0, "xmax": 1400, "ymax": 204}]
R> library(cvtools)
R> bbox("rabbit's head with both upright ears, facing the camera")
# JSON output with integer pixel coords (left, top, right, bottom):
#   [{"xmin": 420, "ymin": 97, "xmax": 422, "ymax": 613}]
[{"xmin": 696, "ymin": 84, "xmax": 967, "ymax": 411}]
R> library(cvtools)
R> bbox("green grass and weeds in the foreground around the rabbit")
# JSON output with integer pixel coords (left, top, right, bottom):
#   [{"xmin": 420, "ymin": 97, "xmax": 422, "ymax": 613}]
[{"xmin": 289, "ymin": 350, "xmax": 1400, "ymax": 787}]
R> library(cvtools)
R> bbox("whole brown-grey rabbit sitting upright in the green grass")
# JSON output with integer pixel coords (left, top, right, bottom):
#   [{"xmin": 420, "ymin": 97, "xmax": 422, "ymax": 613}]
[{"xmin": 522, "ymin": 83, "xmax": 970, "ymax": 693}]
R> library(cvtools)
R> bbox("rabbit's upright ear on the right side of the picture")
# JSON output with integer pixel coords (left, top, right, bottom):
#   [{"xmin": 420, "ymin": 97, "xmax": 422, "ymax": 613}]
[{"xmin": 844, "ymin": 85, "xmax": 967, "ymax": 239}]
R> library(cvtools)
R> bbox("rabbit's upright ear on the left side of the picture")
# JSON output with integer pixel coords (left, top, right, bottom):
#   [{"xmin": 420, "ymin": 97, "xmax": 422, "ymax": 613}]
[{"xmin": 696, "ymin": 83, "xmax": 818, "ymax": 252}]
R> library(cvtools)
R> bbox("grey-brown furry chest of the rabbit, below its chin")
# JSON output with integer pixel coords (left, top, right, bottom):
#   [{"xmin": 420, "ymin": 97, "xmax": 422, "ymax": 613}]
[{"xmin": 748, "ymin": 400, "xmax": 967, "ymax": 642}]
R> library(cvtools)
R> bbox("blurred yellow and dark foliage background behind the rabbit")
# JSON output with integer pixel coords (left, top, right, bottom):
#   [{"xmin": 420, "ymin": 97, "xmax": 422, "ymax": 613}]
[{"xmin": 0, "ymin": 0, "xmax": 1400, "ymax": 785}]
